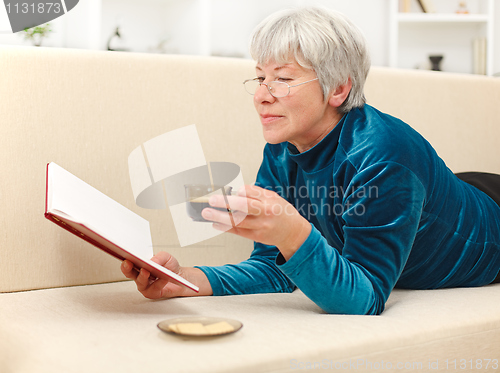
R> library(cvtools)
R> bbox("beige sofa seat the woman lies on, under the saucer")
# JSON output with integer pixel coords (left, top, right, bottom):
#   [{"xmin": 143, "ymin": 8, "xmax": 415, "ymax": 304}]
[{"xmin": 0, "ymin": 281, "xmax": 500, "ymax": 373}]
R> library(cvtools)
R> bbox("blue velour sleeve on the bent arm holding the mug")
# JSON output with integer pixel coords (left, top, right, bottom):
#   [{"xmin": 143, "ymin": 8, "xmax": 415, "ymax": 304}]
[{"xmin": 277, "ymin": 163, "xmax": 425, "ymax": 315}]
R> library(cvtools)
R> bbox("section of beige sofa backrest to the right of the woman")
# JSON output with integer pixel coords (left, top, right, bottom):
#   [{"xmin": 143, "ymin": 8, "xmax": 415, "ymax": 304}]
[{"xmin": 365, "ymin": 67, "xmax": 500, "ymax": 174}]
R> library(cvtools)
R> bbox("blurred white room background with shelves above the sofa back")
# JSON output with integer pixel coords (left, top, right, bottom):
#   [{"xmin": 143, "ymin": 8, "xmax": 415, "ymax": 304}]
[{"xmin": 0, "ymin": 0, "xmax": 500, "ymax": 75}]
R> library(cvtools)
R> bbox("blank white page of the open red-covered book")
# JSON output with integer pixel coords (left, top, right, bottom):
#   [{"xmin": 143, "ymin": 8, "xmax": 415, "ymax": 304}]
[{"xmin": 47, "ymin": 163, "xmax": 153, "ymax": 260}]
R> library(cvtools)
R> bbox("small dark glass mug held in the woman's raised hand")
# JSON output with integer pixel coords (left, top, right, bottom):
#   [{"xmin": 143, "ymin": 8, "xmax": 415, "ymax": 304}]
[{"xmin": 184, "ymin": 184, "xmax": 232, "ymax": 222}]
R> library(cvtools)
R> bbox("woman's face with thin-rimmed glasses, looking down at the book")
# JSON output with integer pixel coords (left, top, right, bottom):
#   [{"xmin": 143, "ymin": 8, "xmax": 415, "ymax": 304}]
[{"xmin": 254, "ymin": 61, "xmax": 342, "ymax": 152}]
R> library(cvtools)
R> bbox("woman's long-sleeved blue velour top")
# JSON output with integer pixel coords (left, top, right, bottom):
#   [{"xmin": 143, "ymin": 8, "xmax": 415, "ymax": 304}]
[{"xmin": 198, "ymin": 105, "xmax": 500, "ymax": 314}]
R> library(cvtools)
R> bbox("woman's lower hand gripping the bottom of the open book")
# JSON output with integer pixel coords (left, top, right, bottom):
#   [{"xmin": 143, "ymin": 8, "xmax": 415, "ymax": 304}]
[{"xmin": 121, "ymin": 252, "xmax": 212, "ymax": 299}]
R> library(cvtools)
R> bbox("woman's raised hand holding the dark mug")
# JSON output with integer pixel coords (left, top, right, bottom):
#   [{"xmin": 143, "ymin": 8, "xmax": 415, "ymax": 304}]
[{"xmin": 202, "ymin": 185, "xmax": 311, "ymax": 260}]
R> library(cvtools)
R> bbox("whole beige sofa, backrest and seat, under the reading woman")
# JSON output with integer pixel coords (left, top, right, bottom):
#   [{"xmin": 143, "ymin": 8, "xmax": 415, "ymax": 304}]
[{"xmin": 0, "ymin": 47, "xmax": 500, "ymax": 373}]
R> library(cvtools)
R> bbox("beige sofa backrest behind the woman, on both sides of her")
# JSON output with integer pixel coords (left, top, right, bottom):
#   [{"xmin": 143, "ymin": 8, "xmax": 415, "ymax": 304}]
[{"xmin": 0, "ymin": 47, "xmax": 500, "ymax": 292}]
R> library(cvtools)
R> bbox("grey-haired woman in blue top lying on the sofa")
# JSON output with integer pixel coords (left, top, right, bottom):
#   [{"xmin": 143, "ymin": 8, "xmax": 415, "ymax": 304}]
[{"xmin": 122, "ymin": 8, "xmax": 500, "ymax": 314}]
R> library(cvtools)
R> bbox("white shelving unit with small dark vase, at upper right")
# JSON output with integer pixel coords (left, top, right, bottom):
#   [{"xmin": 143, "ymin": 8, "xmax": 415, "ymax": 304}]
[{"xmin": 389, "ymin": 0, "xmax": 494, "ymax": 75}]
